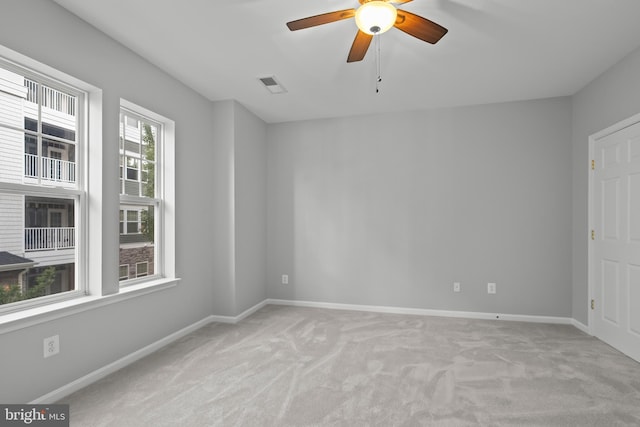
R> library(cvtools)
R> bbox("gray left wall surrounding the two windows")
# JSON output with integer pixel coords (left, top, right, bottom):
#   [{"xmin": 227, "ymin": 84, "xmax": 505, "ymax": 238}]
[{"xmin": 0, "ymin": 0, "xmax": 219, "ymax": 403}]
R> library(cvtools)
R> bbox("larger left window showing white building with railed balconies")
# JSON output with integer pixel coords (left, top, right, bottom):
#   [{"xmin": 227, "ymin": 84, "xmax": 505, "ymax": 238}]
[{"xmin": 0, "ymin": 59, "xmax": 86, "ymax": 311}]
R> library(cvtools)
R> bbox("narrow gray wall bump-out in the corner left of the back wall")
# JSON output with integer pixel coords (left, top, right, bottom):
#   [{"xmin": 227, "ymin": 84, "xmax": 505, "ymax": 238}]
[{"xmin": 211, "ymin": 101, "xmax": 267, "ymax": 316}]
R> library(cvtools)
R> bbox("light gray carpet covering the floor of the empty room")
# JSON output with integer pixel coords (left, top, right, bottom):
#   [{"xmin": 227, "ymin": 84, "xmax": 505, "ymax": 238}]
[{"xmin": 60, "ymin": 306, "xmax": 640, "ymax": 427}]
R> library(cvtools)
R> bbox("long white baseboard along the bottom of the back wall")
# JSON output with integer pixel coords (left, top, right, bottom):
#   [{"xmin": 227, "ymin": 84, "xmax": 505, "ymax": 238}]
[{"xmin": 266, "ymin": 299, "xmax": 580, "ymax": 329}]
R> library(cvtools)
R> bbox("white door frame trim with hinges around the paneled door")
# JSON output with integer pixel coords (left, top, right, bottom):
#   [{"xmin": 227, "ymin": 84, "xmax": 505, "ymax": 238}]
[{"xmin": 586, "ymin": 113, "xmax": 640, "ymax": 335}]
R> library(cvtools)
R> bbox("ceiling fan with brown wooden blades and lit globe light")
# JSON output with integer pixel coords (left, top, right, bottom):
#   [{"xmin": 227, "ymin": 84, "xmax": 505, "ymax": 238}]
[{"xmin": 287, "ymin": 0, "xmax": 448, "ymax": 62}]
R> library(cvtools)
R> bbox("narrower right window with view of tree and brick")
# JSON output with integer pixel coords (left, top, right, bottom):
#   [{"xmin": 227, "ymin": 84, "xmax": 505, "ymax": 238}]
[{"xmin": 119, "ymin": 108, "xmax": 164, "ymax": 285}]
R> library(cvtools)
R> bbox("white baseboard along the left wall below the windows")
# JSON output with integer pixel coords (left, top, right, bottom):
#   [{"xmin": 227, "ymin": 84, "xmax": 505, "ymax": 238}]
[{"xmin": 30, "ymin": 316, "xmax": 213, "ymax": 405}]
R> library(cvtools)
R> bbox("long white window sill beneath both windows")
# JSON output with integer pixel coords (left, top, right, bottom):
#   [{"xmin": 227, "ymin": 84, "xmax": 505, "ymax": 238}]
[{"xmin": 0, "ymin": 278, "xmax": 180, "ymax": 335}]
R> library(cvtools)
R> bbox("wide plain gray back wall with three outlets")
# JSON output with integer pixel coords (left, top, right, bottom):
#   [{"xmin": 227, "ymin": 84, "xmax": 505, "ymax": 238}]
[{"xmin": 267, "ymin": 98, "xmax": 571, "ymax": 316}]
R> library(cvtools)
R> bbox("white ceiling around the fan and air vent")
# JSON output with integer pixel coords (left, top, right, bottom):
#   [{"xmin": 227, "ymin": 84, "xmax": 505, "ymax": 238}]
[{"xmin": 54, "ymin": 0, "xmax": 640, "ymax": 123}]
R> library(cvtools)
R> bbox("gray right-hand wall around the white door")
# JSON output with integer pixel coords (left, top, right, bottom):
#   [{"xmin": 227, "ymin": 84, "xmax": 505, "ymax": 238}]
[{"xmin": 572, "ymin": 49, "xmax": 640, "ymax": 324}]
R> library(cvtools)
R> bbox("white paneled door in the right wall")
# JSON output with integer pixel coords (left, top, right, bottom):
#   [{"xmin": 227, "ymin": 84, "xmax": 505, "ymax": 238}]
[{"xmin": 589, "ymin": 116, "xmax": 640, "ymax": 361}]
